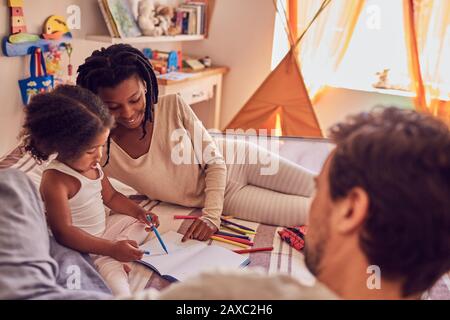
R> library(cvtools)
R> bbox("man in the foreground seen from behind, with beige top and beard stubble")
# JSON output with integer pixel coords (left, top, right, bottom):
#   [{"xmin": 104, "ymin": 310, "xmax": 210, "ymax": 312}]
[{"xmin": 135, "ymin": 108, "xmax": 450, "ymax": 300}]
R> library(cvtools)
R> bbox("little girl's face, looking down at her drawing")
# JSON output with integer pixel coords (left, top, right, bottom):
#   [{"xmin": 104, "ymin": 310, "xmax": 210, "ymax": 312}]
[{"xmin": 64, "ymin": 129, "xmax": 110, "ymax": 173}]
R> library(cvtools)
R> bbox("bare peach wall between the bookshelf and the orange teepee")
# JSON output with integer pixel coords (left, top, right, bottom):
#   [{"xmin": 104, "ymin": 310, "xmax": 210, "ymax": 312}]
[{"xmin": 183, "ymin": 0, "xmax": 275, "ymax": 128}]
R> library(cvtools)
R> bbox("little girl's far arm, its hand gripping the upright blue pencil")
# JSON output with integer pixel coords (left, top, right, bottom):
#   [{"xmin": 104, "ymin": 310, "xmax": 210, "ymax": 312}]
[{"xmin": 102, "ymin": 174, "xmax": 159, "ymax": 228}]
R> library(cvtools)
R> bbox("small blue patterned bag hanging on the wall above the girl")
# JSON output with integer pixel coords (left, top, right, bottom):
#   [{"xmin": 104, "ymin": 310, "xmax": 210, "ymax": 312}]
[{"xmin": 19, "ymin": 47, "xmax": 55, "ymax": 105}]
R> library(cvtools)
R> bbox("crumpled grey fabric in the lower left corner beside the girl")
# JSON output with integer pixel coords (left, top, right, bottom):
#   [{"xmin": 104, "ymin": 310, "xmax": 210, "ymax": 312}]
[{"xmin": 0, "ymin": 169, "xmax": 111, "ymax": 300}]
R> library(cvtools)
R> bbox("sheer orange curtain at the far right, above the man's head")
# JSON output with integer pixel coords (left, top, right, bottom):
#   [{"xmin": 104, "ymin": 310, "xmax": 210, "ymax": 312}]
[{"xmin": 403, "ymin": 0, "xmax": 450, "ymax": 125}]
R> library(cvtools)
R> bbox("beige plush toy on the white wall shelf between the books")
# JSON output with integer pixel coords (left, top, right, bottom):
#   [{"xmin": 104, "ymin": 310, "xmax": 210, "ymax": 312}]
[{"xmin": 138, "ymin": 0, "xmax": 173, "ymax": 37}]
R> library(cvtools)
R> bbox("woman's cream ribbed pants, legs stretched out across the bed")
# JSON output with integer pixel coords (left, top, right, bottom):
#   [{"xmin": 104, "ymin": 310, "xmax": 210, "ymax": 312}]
[{"xmin": 223, "ymin": 141, "xmax": 314, "ymax": 226}]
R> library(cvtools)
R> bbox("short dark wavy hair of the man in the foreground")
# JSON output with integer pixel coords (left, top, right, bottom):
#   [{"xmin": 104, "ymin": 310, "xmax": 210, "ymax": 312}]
[{"xmin": 329, "ymin": 107, "xmax": 450, "ymax": 297}]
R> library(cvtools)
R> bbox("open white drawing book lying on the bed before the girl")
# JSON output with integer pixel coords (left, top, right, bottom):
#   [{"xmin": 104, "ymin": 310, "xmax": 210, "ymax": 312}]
[{"xmin": 138, "ymin": 231, "xmax": 250, "ymax": 282}]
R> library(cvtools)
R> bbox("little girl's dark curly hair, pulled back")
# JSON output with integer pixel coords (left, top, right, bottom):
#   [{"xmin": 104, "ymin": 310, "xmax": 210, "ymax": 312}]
[{"xmin": 21, "ymin": 85, "xmax": 114, "ymax": 162}]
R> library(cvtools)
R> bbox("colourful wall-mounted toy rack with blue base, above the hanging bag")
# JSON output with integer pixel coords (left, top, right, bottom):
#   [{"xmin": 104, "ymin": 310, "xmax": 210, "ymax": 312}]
[{"xmin": 2, "ymin": 0, "xmax": 72, "ymax": 57}]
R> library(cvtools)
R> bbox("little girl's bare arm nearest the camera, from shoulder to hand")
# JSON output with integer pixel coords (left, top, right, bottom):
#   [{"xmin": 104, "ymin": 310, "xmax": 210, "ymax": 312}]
[{"xmin": 41, "ymin": 172, "xmax": 142, "ymax": 262}]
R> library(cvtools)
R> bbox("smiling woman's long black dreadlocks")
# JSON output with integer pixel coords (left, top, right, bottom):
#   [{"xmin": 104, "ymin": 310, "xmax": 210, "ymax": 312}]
[{"xmin": 77, "ymin": 44, "xmax": 159, "ymax": 166}]
